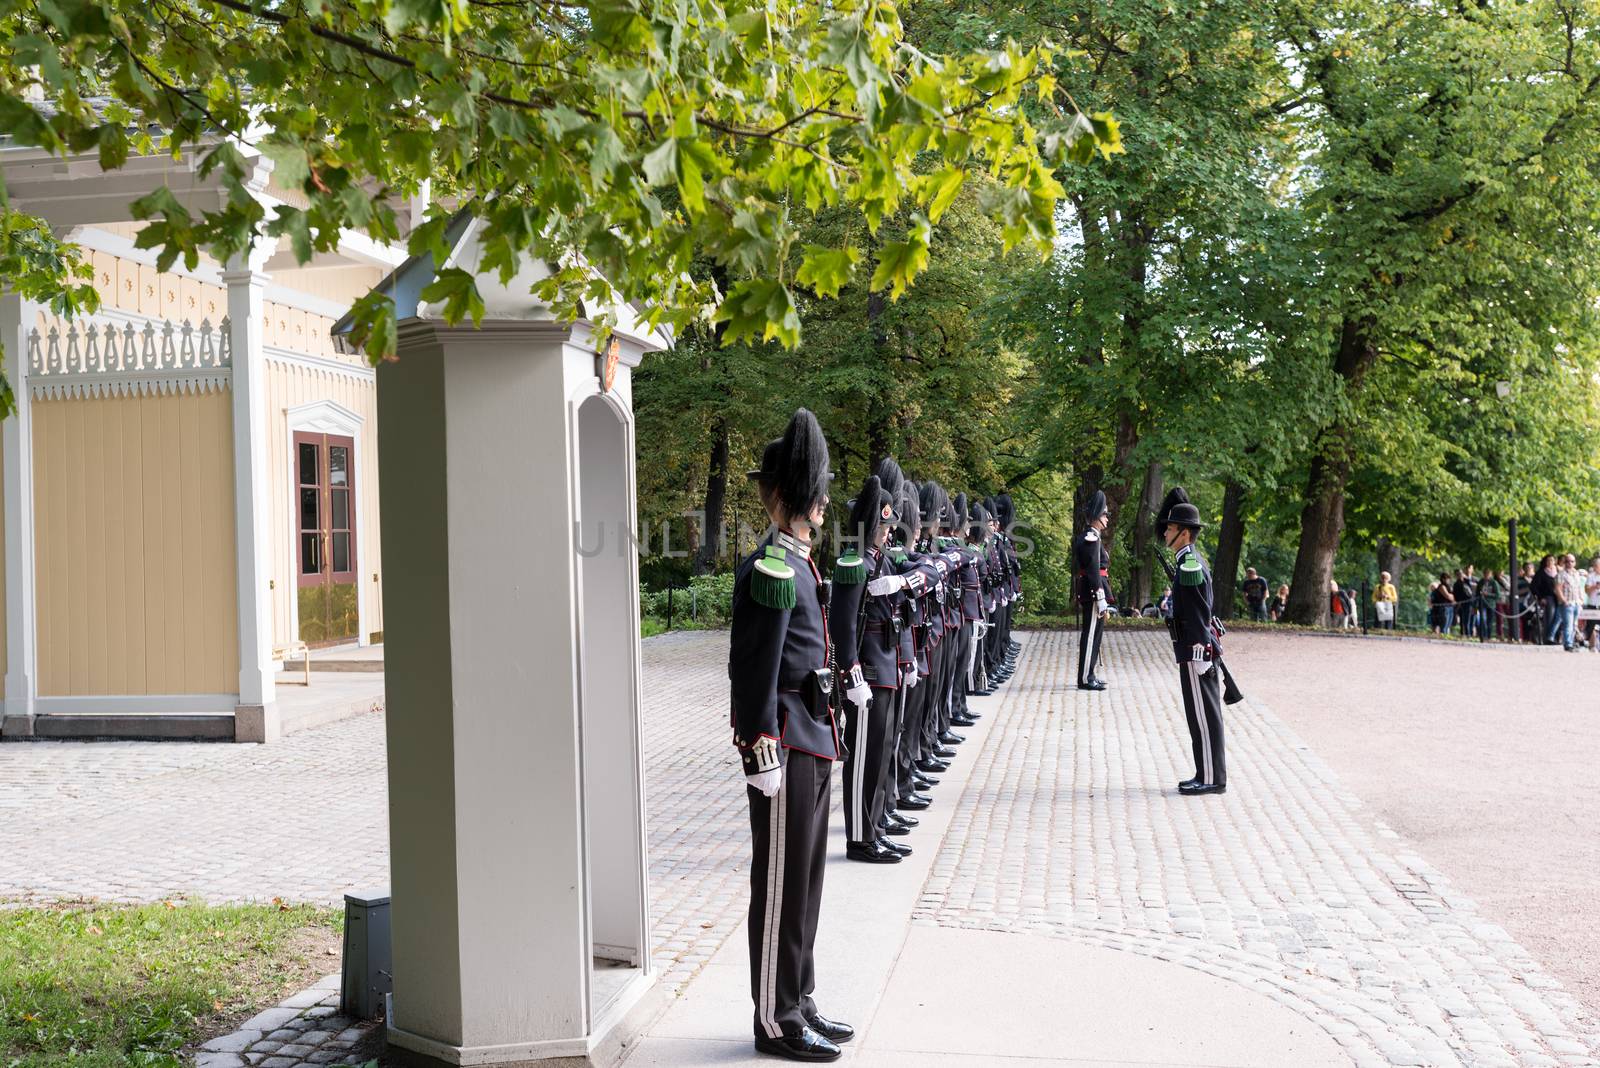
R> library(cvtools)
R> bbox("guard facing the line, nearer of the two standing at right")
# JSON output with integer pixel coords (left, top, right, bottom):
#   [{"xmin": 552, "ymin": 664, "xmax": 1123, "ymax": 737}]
[{"xmin": 1155, "ymin": 489, "xmax": 1227, "ymax": 795}]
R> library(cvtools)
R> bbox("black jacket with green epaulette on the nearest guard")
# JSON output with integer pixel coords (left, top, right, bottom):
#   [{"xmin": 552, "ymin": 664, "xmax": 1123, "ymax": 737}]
[{"xmin": 728, "ymin": 531, "xmax": 838, "ymax": 775}]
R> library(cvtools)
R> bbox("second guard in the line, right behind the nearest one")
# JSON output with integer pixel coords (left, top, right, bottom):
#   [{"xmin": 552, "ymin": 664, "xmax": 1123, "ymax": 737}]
[{"xmin": 829, "ymin": 475, "xmax": 912, "ymax": 863}]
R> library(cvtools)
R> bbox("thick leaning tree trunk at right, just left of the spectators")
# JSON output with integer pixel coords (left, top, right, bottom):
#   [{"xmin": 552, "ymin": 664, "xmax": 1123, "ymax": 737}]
[{"xmin": 1283, "ymin": 320, "xmax": 1378, "ymax": 627}]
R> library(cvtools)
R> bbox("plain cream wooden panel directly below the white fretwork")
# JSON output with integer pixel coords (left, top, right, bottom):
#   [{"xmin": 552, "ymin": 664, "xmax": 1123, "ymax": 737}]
[{"xmin": 34, "ymin": 392, "xmax": 238, "ymax": 697}]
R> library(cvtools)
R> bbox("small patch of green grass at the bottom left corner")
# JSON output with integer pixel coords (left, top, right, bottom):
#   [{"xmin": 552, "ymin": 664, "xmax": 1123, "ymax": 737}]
[{"xmin": 0, "ymin": 902, "xmax": 344, "ymax": 1068}]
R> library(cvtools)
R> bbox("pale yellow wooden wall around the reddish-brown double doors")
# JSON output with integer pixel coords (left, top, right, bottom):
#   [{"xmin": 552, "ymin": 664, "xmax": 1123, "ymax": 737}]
[{"xmin": 267, "ymin": 357, "xmax": 384, "ymax": 644}]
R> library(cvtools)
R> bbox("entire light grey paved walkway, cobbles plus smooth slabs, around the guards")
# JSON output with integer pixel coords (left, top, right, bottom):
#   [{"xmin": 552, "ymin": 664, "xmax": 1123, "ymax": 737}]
[{"xmin": 0, "ymin": 632, "xmax": 1600, "ymax": 1068}]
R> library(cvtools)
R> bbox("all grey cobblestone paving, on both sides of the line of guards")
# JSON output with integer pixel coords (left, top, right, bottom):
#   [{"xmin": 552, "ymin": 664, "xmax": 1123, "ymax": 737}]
[{"xmin": 0, "ymin": 632, "xmax": 1600, "ymax": 1068}]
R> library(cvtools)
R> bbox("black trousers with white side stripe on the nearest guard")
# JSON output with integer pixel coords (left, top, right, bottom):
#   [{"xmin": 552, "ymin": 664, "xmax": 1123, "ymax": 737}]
[{"xmin": 746, "ymin": 750, "xmax": 834, "ymax": 1038}]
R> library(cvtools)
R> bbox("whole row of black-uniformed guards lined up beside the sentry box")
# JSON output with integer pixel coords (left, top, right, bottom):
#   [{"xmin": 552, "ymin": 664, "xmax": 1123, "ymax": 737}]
[{"xmin": 728, "ymin": 408, "xmax": 1022, "ymax": 1060}]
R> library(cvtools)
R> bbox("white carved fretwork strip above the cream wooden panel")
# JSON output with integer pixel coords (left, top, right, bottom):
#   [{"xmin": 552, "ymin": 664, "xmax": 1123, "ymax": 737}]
[{"xmin": 27, "ymin": 317, "xmax": 234, "ymax": 400}]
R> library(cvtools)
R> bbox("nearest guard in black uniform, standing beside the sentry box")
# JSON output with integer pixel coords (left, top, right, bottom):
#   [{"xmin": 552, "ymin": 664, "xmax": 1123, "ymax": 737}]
[{"xmin": 728, "ymin": 408, "xmax": 854, "ymax": 1060}]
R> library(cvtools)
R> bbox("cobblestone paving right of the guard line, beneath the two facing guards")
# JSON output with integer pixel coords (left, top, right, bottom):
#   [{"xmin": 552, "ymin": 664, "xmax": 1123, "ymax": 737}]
[{"xmin": 915, "ymin": 632, "xmax": 1600, "ymax": 1068}]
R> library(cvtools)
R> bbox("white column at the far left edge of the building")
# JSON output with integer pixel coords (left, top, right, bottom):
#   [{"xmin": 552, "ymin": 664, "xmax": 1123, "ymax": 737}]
[{"xmin": 0, "ymin": 293, "xmax": 38, "ymax": 737}]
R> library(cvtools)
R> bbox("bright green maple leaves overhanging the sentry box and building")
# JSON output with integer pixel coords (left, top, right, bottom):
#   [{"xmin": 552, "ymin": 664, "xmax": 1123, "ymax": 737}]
[{"xmin": 0, "ymin": 0, "xmax": 1118, "ymax": 412}]
